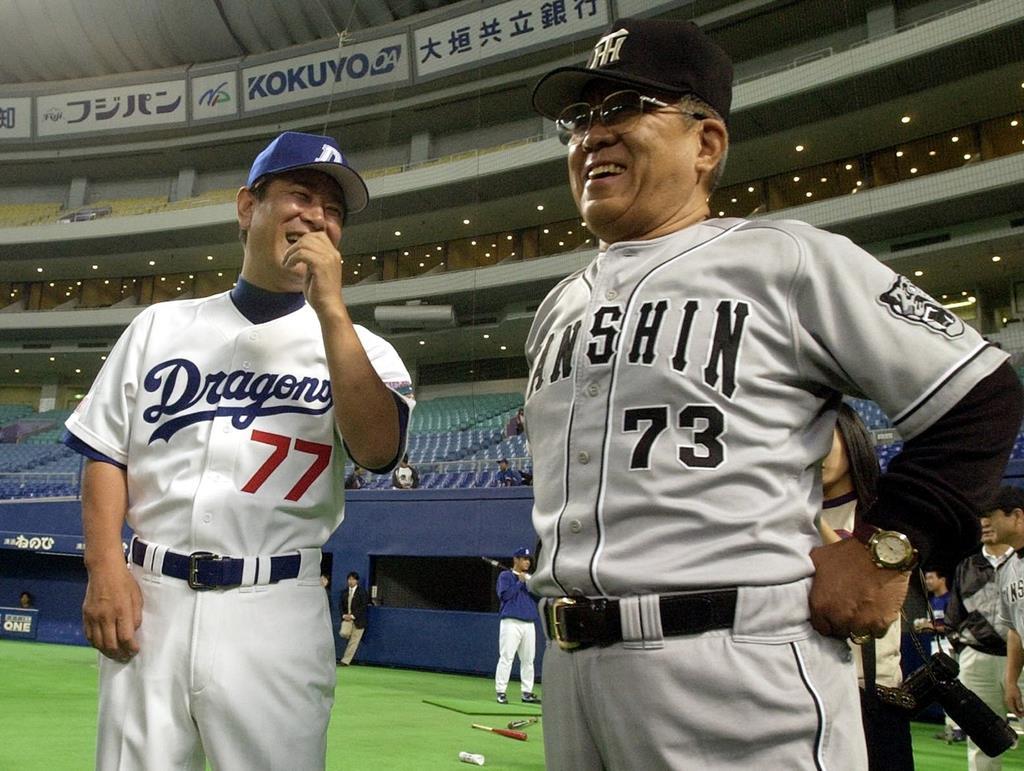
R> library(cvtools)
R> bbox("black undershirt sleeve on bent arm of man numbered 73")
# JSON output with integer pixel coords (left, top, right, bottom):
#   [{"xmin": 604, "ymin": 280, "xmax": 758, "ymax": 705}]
[{"xmin": 865, "ymin": 363, "xmax": 1024, "ymax": 575}]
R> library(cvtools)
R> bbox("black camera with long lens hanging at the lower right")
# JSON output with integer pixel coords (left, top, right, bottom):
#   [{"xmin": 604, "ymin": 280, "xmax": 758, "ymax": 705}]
[{"xmin": 901, "ymin": 653, "xmax": 1017, "ymax": 758}]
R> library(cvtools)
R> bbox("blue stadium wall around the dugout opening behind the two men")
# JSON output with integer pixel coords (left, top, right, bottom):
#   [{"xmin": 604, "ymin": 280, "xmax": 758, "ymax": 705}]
[{"xmin": 0, "ymin": 487, "xmax": 544, "ymax": 674}]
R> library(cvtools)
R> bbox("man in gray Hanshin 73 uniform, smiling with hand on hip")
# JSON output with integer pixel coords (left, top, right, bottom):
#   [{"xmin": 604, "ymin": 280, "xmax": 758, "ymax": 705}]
[{"xmin": 525, "ymin": 18, "xmax": 1021, "ymax": 770}]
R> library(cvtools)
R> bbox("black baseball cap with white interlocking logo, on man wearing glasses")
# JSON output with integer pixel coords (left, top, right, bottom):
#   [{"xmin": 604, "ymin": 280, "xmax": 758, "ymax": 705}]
[{"xmin": 534, "ymin": 18, "xmax": 732, "ymax": 122}]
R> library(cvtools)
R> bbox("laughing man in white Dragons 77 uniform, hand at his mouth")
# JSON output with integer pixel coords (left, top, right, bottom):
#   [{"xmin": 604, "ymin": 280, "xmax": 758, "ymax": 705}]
[{"xmin": 66, "ymin": 132, "xmax": 413, "ymax": 771}]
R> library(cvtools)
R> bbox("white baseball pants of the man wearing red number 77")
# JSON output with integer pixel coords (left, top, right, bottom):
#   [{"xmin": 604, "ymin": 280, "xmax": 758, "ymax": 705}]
[{"xmin": 96, "ymin": 550, "xmax": 337, "ymax": 771}]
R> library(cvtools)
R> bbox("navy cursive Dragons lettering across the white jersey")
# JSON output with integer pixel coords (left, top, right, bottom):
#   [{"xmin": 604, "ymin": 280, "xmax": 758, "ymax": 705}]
[{"xmin": 142, "ymin": 358, "xmax": 333, "ymax": 444}]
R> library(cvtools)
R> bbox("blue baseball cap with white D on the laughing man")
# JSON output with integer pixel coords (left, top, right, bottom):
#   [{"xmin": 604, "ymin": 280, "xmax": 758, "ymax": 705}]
[{"xmin": 246, "ymin": 131, "xmax": 370, "ymax": 214}]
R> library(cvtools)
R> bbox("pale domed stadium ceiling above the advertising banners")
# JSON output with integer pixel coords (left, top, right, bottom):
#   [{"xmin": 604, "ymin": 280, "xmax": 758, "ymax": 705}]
[{"xmin": 0, "ymin": 0, "xmax": 455, "ymax": 84}]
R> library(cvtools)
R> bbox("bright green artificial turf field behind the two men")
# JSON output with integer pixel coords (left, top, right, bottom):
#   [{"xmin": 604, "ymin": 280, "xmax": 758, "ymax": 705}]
[{"xmin": 6, "ymin": 640, "xmax": 1024, "ymax": 771}]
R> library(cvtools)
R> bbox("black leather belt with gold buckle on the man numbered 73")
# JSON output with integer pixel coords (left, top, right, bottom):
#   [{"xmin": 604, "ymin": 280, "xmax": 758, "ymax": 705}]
[{"xmin": 547, "ymin": 589, "xmax": 736, "ymax": 650}]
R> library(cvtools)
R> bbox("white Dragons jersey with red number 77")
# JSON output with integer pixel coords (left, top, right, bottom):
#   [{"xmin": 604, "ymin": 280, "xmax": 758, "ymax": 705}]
[{"xmin": 67, "ymin": 293, "xmax": 413, "ymax": 556}]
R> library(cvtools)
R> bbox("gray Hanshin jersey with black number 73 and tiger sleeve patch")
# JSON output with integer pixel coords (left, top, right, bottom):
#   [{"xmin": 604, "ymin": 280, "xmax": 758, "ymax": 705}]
[{"xmin": 525, "ymin": 219, "xmax": 1007, "ymax": 596}]
